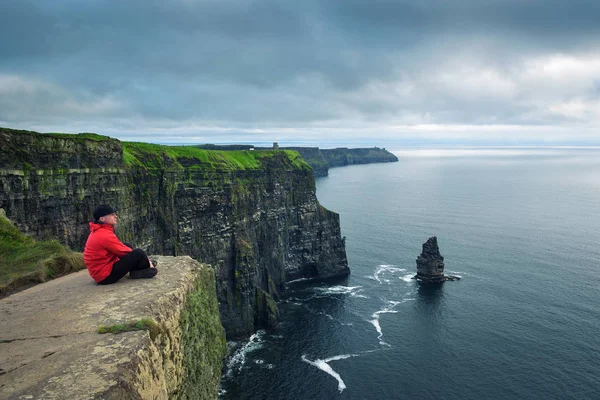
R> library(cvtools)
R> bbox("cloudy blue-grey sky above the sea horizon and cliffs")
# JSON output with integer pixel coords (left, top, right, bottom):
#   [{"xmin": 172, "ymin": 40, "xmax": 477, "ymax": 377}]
[{"xmin": 0, "ymin": 0, "xmax": 600, "ymax": 146}]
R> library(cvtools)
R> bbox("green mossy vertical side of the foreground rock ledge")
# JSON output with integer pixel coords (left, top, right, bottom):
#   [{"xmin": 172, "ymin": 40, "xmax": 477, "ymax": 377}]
[{"xmin": 175, "ymin": 268, "xmax": 226, "ymax": 399}]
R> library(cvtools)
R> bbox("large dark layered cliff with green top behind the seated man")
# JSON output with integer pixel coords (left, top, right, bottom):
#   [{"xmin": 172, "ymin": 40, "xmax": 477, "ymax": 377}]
[{"xmin": 0, "ymin": 129, "xmax": 349, "ymax": 337}]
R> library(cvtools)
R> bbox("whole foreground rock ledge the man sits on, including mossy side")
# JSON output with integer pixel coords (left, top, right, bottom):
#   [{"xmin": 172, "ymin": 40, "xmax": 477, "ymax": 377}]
[{"xmin": 0, "ymin": 256, "xmax": 225, "ymax": 399}]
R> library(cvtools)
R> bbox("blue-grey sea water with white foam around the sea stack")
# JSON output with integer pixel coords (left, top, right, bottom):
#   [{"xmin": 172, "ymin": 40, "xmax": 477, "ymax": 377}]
[{"xmin": 220, "ymin": 148, "xmax": 600, "ymax": 399}]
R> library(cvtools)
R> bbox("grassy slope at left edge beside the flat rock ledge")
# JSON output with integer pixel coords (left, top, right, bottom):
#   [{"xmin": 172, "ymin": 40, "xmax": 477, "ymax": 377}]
[{"xmin": 0, "ymin": 209, "xmax": 85, "ymax": 298}]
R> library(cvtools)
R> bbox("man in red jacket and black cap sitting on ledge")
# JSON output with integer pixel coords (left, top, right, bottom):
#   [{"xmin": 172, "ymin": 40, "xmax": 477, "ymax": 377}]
[{"xmin": 83, "ymin": 204, "xmax": 158, "ymax": 285}]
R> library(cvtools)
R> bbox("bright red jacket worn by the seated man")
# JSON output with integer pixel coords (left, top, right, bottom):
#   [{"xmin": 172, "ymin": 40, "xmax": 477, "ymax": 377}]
[{"xmin": 83, "ymin": 222, "xmax": 131, "ymax": 282}]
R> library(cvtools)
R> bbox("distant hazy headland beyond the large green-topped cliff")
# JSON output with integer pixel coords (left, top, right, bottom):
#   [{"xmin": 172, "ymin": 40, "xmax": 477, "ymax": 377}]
[{"xmin": 195, "ymin": 144, "xmax": 398, "ymax": 177}]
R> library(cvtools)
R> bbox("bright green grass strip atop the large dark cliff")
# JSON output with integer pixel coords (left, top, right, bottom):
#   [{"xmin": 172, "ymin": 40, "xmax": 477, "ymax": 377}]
[{"xmin": 122, "ymin": 142, "xmax": 310, "ymax": 171}]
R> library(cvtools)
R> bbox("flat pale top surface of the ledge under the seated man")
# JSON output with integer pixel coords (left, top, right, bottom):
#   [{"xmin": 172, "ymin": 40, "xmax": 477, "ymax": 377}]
[{"xmin": 0, "ymin": 256, "xmax": 199, "ymax": 399}]
